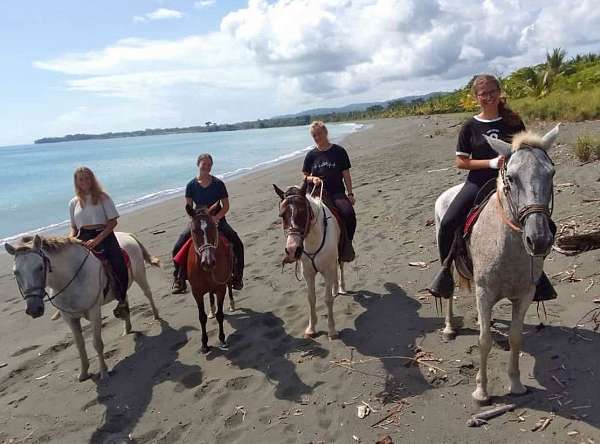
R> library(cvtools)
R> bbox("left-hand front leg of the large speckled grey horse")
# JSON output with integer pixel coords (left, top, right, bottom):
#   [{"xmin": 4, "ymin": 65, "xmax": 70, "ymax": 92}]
[{"xmin": 471, "ymin": 286, "xmax": 493, "ymax": 404}]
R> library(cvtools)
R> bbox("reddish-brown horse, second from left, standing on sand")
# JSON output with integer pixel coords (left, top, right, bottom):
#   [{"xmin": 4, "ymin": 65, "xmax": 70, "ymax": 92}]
[{"xmin": 186, "ymin": 206, "xmax": 233, "ymax": 353}]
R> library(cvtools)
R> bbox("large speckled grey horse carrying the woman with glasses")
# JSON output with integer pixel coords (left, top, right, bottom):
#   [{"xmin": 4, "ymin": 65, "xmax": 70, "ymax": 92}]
[{"xmin": 435, "ymin": 125, "xmax": 559, "ymax": 404}]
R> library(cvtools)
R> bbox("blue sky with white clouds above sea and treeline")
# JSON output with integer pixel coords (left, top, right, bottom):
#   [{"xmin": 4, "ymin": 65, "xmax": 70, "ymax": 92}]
[{"xmin": 0, "ymin": 0, "xmax": 600, "ymax": 145}]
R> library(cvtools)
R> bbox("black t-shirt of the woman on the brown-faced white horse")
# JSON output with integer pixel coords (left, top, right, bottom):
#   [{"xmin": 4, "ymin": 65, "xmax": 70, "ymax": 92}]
[{"xmin": 302, "ymin": 144, "xmax": 352, "ymax": 195}]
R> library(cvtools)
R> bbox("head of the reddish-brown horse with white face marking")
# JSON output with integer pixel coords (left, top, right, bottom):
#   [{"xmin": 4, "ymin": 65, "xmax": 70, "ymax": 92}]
[{"xmin": 185, "ymin": 205, "xmax": 219, "ymax": 271}]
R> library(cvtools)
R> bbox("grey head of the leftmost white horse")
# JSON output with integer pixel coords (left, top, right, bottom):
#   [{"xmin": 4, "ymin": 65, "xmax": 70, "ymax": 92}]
[{"xmin": 4, "ymin": 235, "xmax": 50, "ymax": 318}]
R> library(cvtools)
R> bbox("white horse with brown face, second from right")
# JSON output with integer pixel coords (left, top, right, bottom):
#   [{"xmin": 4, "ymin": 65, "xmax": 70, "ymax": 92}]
[{"xmin": 273, "ymin": 182, "xmax": 346, "ymax": 340}]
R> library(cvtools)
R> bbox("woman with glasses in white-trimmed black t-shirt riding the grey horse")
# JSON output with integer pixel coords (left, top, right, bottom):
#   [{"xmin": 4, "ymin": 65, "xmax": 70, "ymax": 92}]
[{"xmin": 429, "ymin": 75, "xmax": 556, "ymax": 300}]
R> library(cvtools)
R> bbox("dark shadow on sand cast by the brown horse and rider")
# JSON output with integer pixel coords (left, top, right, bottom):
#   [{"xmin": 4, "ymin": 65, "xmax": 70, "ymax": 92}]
[{"xmin": 207, "ymin": 308, "xmax": 329, "ymax": 402}]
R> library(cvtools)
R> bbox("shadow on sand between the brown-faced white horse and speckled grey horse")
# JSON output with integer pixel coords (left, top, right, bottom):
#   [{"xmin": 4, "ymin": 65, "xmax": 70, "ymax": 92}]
[{"xmin": 338, "ymin": 282, "xmax": 441, "ymax": 403}]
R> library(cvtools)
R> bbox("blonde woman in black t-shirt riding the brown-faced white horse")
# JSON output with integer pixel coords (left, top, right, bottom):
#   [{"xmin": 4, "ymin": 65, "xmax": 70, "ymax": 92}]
[{"xmin": 302, "ymin": 121, "xmax": 356, "ymax": 262}]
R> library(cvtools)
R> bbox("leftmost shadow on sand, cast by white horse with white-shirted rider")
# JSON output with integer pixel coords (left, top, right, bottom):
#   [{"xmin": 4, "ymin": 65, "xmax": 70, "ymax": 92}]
[{"xmin": 89, "ymin": 320, "xmax": 202, "ymax": 444}]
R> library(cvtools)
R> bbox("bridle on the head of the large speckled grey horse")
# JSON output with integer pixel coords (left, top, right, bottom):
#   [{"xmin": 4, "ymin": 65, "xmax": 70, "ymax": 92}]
[{"xmin": 496, "ymin": 145, "xmax": 554, "ymax": 233}]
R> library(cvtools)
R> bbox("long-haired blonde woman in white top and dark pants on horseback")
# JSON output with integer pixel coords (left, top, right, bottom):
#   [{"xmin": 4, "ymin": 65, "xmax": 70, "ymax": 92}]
[{"xmin": 69, "ymin": 167, "xmax": 129, "ymax": 318}]
